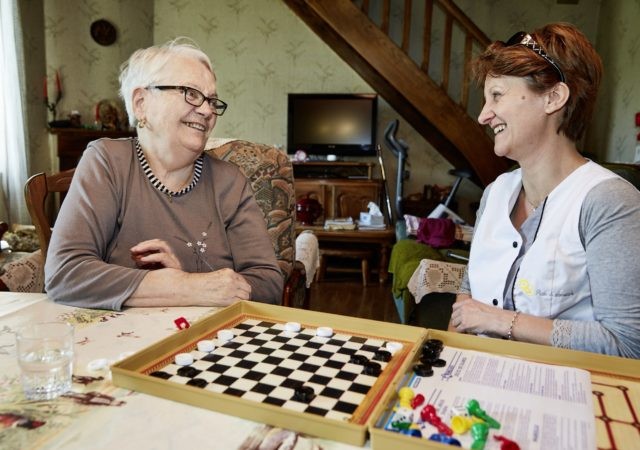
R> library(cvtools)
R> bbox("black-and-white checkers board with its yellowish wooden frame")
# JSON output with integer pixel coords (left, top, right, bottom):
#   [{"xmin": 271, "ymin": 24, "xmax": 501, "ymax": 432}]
[{"xmin": 112, "ymin": 302, "xmax": 427, "ymax": 445}]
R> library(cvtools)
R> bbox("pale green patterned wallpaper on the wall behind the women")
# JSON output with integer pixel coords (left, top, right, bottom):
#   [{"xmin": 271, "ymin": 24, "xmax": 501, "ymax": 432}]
[{"xmin": 27, "ymin": 0, "xmax": 640, "ymax": 218}]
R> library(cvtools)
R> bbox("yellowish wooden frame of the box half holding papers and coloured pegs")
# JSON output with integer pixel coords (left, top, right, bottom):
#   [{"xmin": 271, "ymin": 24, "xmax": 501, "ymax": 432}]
[{"xmin": 370, "ymin": 329, "xmax": 640, "ymax": 450}]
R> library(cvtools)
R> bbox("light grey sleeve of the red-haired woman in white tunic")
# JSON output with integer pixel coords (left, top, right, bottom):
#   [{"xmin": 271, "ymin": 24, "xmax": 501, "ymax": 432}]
[{"xmin": 552, "ymin": 179, "xmax": 640, "ymax": 358}]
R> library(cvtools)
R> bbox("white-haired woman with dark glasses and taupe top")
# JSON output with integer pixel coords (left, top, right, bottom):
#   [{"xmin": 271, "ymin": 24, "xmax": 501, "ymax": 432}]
[{"xmin": 45, "ymin": 40, "xmax": 283, "ymax": 310}]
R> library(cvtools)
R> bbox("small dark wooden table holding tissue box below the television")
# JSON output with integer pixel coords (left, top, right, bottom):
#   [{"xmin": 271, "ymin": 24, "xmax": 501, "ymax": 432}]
[{"xmin": 296, "ymin": 225, "xmax": 396, "ymax": 284}]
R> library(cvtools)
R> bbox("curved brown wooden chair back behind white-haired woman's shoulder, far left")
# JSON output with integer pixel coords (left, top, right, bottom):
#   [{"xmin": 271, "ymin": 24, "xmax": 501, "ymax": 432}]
[{"xmin": 24, "ymin": 169, "xmax": 75, "ymax": 260}]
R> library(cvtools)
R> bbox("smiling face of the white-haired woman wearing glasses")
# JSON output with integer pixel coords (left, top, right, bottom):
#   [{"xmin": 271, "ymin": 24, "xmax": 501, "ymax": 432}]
[{"xmin": 134, "ymin": 55, "xmax": 217, "ymax": 159}]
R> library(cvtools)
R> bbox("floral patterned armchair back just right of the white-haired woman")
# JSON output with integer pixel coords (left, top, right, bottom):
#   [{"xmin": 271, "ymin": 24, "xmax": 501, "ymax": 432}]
[{"xmin": 206, "ymin": 139, "xmax": 308, "ymax": 308}]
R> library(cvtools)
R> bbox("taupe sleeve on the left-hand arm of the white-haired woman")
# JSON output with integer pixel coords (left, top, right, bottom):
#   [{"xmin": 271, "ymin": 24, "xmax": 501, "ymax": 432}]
[{"xmin": 45, "ymin": 142, "xmax": 147, "ymax": 310}]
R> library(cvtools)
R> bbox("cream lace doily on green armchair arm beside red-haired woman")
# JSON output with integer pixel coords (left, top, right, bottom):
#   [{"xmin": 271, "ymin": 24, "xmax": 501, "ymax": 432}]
[{"xmin": 407, "ymin": 259, "xmax": 466, "ymax": 303}]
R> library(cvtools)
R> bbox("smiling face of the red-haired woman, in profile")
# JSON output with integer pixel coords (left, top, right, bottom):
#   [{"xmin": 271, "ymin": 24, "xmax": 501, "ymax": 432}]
[{"xmin": 478, "ymin": 76, "xmax": 548, "ymax": 161}]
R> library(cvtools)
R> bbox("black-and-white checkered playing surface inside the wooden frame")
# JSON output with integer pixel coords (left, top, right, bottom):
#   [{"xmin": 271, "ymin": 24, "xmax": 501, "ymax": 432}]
[{"xmin": 149, "ymin": 319, "xmax": 396, "ymax": 421}]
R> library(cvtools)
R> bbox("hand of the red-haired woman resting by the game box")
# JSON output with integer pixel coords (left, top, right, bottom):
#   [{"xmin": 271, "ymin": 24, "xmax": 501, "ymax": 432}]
[{"xmin": 450, "ymin": 296, "xmax": 502, "ymax": 334}]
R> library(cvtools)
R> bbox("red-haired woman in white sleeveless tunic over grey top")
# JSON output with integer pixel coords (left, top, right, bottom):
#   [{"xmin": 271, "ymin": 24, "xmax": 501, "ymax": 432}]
[{"xmin": 449, "ymin": 23, "xmax": 640, "ymax": 358}]
